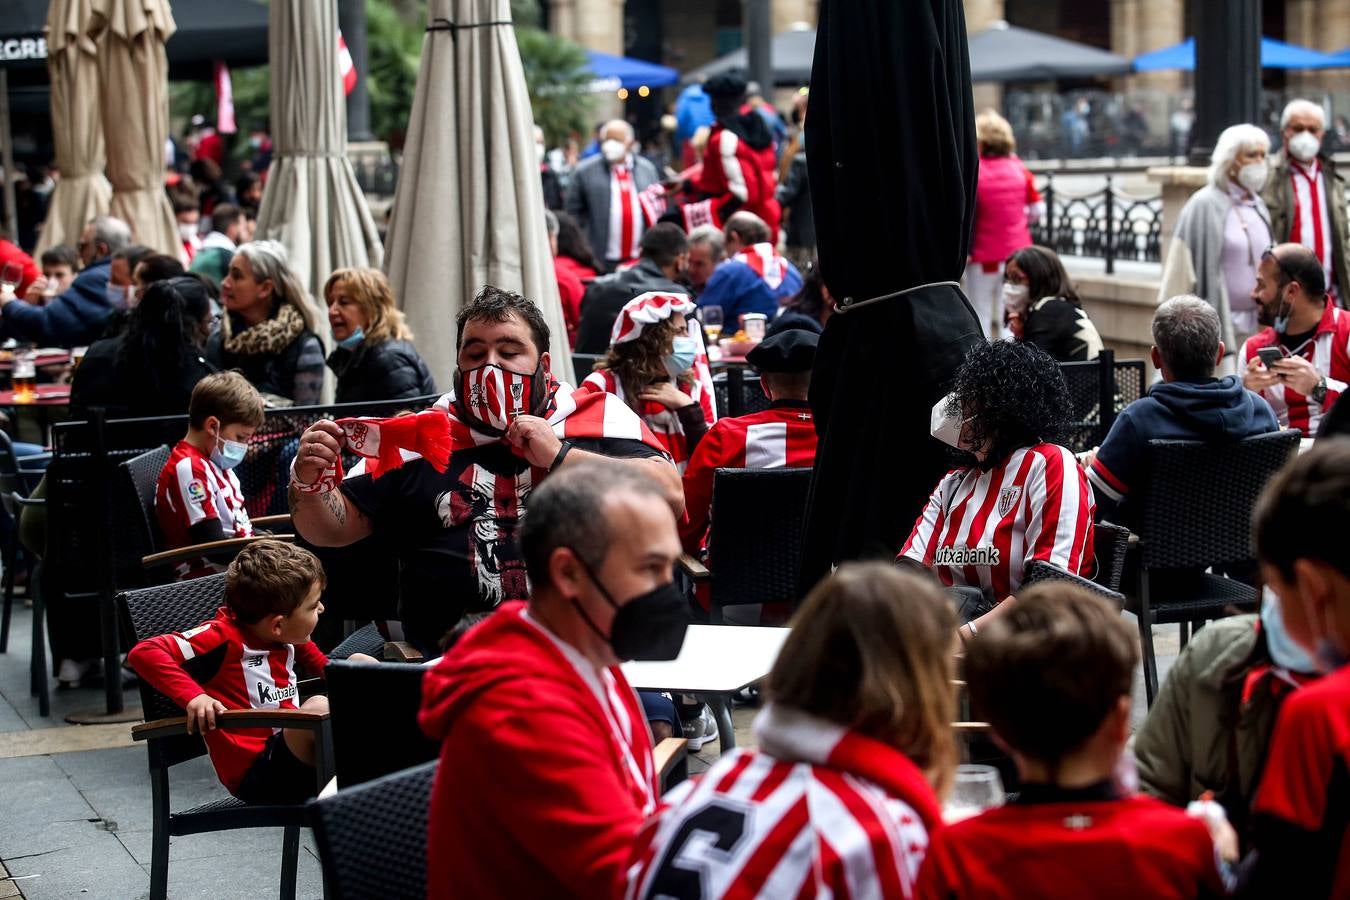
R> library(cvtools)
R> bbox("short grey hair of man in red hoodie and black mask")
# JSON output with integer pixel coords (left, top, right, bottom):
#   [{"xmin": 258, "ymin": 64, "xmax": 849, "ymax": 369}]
[{"xmin": 520, "ymin": 461, "xmax": 666, "ymax": 588}]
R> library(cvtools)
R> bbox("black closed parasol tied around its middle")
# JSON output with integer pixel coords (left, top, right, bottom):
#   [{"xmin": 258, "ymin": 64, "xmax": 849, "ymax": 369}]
[{"xmin": 802, "ymin": 0, "xmax": 983, "ymax": 588}]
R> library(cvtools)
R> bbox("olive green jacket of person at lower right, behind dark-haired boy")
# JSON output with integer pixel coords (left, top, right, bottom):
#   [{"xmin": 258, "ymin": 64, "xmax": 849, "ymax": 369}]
[{"xmin": 1134, "ymin": 614, "xmax": 1292, "ymax": 834}]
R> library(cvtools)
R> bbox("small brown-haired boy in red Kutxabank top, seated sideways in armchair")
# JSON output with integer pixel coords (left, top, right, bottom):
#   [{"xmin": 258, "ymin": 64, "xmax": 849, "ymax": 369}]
[{"xmin": 127, "ymin": 540, "xmax": 375, "ymax": 804}]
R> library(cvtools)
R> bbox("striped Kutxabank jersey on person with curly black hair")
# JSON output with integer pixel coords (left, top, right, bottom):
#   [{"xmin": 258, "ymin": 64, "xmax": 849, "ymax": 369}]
[{"xmin": 900, "ymin": 444, "xmax": 1096, "ymax": 600}]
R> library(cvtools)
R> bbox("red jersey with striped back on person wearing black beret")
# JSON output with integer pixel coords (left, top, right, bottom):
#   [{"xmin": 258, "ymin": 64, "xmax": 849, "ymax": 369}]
[{"xmin": 679, "ymin": 399, "xmax": 815, "ymax": 553}]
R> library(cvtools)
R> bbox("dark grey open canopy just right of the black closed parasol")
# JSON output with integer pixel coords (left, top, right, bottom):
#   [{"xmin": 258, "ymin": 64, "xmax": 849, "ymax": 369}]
[{"xmin": 969, "ymin": 22, "xmax": 1130, "ymax": 81}]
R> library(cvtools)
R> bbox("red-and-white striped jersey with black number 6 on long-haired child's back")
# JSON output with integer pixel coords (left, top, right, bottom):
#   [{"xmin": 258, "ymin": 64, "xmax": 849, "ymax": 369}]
[{"xmin": 625, "ymin": 706, "xmax": 941, "ymax": 900}]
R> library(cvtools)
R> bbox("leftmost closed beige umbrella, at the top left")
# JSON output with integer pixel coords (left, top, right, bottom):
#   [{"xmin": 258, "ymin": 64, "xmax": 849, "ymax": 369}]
[{"xmin": 38, "ymin": 0, "xmax": 112, "ymax": 252}]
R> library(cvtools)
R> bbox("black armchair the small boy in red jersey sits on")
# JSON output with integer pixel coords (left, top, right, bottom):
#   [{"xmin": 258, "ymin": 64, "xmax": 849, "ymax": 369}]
[{"xmin": 117, "ymin": 575, "xmax": 332, "ymax": 900}]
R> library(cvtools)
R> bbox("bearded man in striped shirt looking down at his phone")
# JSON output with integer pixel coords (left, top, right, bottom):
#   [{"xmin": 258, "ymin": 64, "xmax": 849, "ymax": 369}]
[{"xmin": 1238, "ymin": 244, "xmax": 1350, "ymax": 437}]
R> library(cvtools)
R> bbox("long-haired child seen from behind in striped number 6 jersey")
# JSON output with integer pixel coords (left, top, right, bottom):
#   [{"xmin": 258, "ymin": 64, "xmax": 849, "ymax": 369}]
[{"xmin": 625, "ymin": 563, "xmax": 956, "ymax": 899}]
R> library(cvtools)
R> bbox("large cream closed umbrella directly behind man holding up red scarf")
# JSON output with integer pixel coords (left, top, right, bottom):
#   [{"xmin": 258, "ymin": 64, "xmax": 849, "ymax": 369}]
[{"xmin": 389, "ymin": 0, "xmax": 572, "ymax": 385}]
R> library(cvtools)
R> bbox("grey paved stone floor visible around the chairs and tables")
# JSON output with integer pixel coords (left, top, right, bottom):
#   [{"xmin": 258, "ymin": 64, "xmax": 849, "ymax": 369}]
[{"xmin": 0, "ymin": 603, "xmax": 1177, "ymax": 900}]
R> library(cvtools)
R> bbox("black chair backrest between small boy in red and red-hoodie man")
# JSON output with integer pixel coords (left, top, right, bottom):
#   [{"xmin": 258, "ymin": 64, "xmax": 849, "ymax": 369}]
[{"xmin": 324, "ymin": 660, "xmax": 440, "ymax": 791}]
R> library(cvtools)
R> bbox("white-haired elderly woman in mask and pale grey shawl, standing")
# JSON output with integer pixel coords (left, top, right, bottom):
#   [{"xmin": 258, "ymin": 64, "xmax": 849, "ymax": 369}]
[{"xmin": 1158, "ymin": 124, "xmax": 1272, "ymax": 358}]
